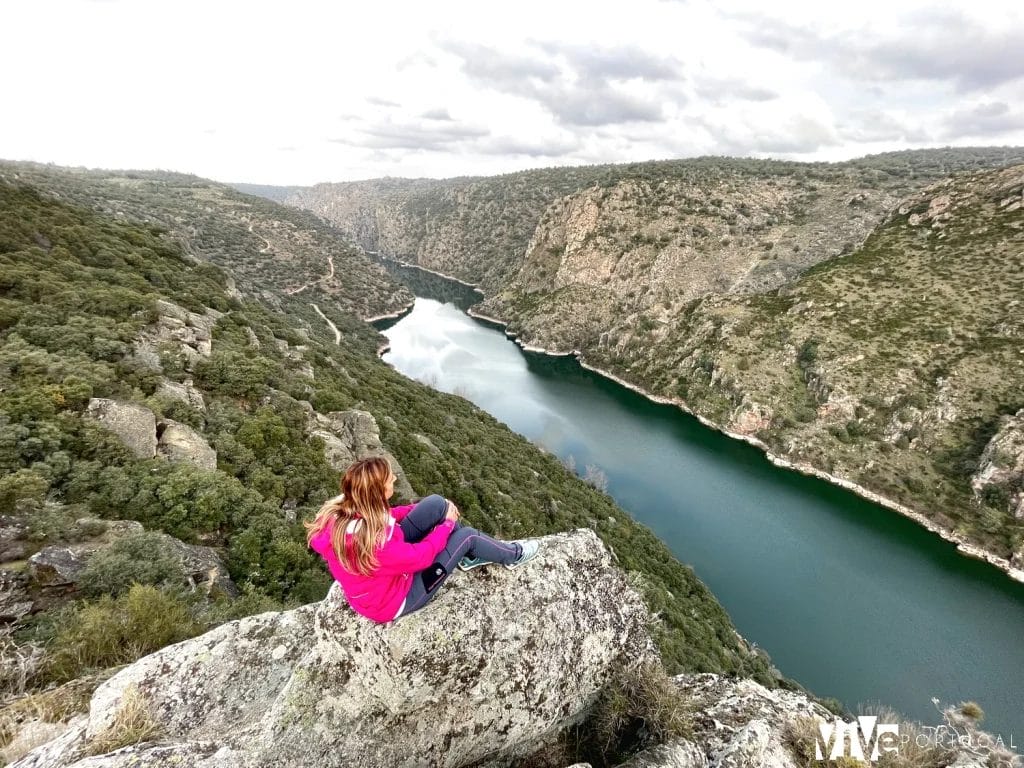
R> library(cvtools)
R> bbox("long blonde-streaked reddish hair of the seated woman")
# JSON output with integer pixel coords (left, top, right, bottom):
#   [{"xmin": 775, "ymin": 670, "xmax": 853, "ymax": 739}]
[{"xmin": 302, "ymin": 457, "xmax": 391, "ymax": 575}]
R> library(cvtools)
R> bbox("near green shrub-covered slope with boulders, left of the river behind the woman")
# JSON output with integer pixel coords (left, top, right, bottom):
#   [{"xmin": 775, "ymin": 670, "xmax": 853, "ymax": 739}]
[{"xmin": 0, "ymin": 169, "xmax": 793, "ymax": 753}]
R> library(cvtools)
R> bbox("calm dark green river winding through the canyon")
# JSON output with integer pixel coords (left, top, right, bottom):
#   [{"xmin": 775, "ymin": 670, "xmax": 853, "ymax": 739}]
[{"xmin": 378, "ymin": 269, "xmax": 1024, "ymax": 751}]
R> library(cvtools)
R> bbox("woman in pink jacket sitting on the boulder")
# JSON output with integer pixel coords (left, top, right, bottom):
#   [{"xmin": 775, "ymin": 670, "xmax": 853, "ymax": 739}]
[{"xmin": 304, "ymin": 458, "xmax": 540, "ymax": 622}]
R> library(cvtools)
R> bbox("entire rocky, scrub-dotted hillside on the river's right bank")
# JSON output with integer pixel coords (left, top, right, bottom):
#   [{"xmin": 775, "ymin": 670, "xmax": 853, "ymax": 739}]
[{"xmin": 290, "ymin": 148, "xmax": 1024, "ymax": 568}]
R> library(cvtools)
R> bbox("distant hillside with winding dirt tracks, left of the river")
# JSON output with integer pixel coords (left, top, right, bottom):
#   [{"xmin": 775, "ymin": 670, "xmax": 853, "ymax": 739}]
[{"xmin": 0, "ymin": 162, "xmax": 412, "ymax": 317}]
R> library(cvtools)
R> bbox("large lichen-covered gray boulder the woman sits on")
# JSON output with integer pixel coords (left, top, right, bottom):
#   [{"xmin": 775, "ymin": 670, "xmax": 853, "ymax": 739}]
[{"xmin": 15, "ymin": 530, "xmax": 656, "ymax": 768}]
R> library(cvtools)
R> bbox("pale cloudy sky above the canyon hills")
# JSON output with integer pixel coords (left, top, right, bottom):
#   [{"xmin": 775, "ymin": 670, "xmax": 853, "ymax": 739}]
[{"xmin": 0, "ymin": 0, "xmax": 1024, "ymax": 184}]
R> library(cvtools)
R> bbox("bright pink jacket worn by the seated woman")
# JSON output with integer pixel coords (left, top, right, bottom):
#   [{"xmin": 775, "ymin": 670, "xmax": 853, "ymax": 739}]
[{"xmin": 309, "ymin": 504, "xmax": 455, "ymax": 622}]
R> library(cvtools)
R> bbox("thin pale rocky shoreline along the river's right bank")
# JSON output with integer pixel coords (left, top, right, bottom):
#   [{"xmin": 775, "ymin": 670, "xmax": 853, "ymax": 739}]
[{"xmin": 466, "ymin": 309, "xmax": 1024, "ymax": 584}]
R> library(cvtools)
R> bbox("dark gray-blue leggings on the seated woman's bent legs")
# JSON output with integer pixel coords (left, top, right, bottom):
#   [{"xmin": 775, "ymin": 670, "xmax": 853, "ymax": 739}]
[{"xmin": 398, "ymin": 494, "xmax": 522, "ymax": 615}]
